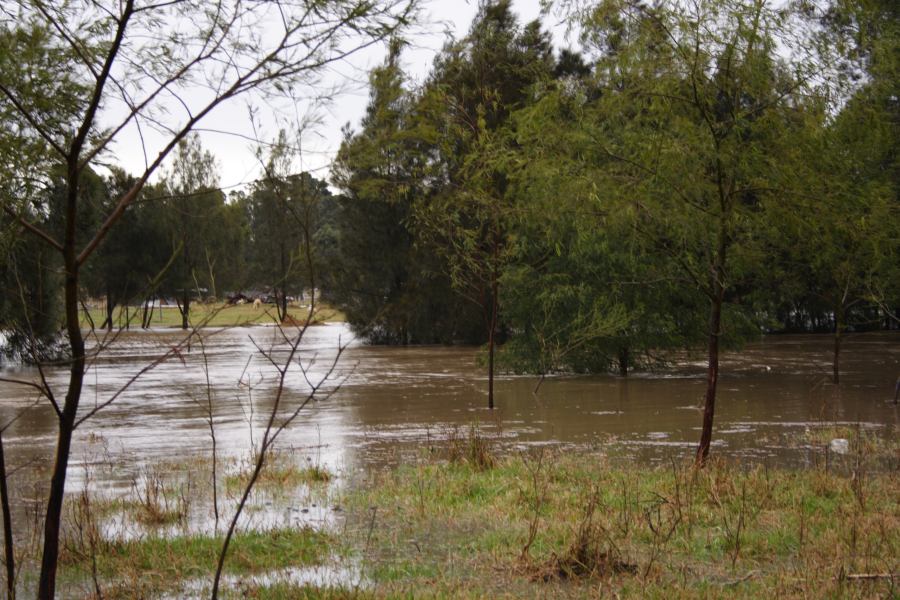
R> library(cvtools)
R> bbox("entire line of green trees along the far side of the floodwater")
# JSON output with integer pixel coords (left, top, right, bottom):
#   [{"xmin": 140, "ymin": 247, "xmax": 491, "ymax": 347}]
[{"xmin": 3, "ymin": 0, "xmax": 900, "ymax": 397}]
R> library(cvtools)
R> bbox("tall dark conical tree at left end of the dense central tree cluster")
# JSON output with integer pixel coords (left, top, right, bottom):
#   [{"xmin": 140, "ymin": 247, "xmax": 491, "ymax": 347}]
[{"xmin": 324, "ymin": 41, "xmax": 480, "ymax": 344}]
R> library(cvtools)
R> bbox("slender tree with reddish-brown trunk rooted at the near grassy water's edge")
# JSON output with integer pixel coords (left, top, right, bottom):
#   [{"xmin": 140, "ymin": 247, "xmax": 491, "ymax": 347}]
[{"xmin": 568, "ymin": 1, "xmax": 828, "ymax": 464}]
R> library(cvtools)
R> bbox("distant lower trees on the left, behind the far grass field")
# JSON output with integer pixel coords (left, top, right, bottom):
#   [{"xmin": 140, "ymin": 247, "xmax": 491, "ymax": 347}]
[{"xmin": 3, "ymin": 135, "xmax": 334, "ymax": 338}]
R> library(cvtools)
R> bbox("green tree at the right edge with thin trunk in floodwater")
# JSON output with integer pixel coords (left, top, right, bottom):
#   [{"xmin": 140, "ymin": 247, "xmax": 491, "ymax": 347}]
[{"xmin": 770, "ymin": 90, "xmax": 900, "ymax": 384}]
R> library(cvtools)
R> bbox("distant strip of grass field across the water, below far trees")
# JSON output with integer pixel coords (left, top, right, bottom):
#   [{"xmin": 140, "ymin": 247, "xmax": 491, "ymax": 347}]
[{"xmin": 81, "ymin": 303, "xmax": 344, "ymax": 328}]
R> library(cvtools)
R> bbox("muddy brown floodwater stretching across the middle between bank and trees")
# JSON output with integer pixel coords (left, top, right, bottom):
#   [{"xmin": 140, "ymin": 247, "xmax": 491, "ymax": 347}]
[{"xmin": 0, "ymin": 325, "xmax": 900, "ymax": 502}]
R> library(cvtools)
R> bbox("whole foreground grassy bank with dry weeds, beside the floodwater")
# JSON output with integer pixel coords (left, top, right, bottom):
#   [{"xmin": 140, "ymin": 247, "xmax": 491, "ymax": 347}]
[{"xmin": 44, "ymin": 435, "xmax": 900, "ymax": 599}]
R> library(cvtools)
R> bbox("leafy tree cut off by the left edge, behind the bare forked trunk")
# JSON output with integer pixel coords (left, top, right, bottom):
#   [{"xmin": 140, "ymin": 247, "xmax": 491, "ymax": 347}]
[{"xmin": 0, "ymin": 18, "xmax": 86, "ymax": 360}]
